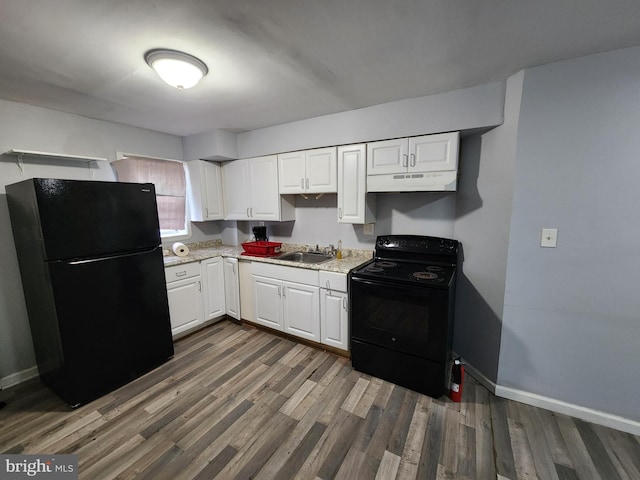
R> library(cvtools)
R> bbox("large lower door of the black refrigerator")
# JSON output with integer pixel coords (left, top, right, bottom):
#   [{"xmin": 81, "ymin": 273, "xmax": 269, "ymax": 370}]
[{"xmin": 43, "ymin": 247, "xmax": 173, "ymax": 405}]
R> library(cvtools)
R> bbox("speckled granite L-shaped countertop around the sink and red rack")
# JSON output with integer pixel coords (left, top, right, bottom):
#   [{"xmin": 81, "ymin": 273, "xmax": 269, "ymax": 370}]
[{"xmin": 164, "ymin": 241, "xmax": 373, "ymax": 273}]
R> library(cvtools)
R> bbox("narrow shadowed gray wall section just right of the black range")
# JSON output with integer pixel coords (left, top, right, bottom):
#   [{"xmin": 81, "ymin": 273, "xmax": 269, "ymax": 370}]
[{"xmin": 454, "ymin": 72, "xmax": 524, "ymax": 383}]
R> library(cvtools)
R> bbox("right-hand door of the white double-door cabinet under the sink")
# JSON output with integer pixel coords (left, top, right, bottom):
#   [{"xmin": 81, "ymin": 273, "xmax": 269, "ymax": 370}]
[{"xmin": 282, "ymin": 282, "xmax": 320, "ymax": 342}]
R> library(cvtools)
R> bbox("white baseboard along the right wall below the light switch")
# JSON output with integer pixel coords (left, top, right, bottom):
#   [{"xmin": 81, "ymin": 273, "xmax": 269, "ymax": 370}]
[{"xmin": 496, "ymin": 384, "xmax": 640, "ymax": 435}]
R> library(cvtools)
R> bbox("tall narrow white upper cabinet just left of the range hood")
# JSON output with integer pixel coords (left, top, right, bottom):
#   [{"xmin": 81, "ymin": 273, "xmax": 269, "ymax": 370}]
[{"xmin": 338, "ymin": 145, "xmax": 375, "ymax": 224}]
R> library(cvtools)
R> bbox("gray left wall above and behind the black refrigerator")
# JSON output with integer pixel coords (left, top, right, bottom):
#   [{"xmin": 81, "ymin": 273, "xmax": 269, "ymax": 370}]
[{"xmin": 0, "ymin": 100, "xmax": 182, "ymax": 385}]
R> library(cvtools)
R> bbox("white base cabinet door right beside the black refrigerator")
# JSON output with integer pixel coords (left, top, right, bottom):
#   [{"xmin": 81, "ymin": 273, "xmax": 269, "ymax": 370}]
[{"xmin": 167, "ymin": 277, "xmax": 202, "ymax": 335}]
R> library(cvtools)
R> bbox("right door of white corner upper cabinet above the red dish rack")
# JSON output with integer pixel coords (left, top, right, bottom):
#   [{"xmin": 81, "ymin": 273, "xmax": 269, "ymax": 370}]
[{"xmin": 247, "ymin": 155, "xmax": 280, "ymax": 221}]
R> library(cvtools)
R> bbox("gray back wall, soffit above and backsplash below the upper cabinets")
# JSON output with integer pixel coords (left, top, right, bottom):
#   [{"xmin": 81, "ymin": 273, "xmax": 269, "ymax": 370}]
[{"xmin": 238, "ymin": 82, "xmax": 505, "ymax": 249}]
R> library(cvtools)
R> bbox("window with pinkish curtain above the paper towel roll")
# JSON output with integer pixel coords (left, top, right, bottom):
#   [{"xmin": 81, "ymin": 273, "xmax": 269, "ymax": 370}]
[{"xmin": 111, "ymin": 155, "xmax": 189, "ymax": 238}]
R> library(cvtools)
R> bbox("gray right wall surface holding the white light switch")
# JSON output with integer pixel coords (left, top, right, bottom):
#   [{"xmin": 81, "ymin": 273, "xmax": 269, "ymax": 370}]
[{"xmin": 498, "ymin": 48, "xmax": 640, "ymax": 420}]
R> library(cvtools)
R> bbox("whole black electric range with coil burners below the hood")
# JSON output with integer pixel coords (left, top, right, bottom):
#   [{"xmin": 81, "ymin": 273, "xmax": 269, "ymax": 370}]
[{"xmin": 349, "ymin": 235, "xmax": 459, "ymax": 397}]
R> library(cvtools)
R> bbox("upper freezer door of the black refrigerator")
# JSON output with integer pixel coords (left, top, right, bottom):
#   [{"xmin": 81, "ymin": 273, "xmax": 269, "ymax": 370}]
[{"xmin": 33, "ymin": 178, "xmax": 160, "ymax": 260}]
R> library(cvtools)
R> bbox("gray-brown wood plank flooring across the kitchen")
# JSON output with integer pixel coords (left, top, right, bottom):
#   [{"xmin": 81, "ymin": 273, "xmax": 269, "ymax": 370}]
[{"xmin": 0, "ymin": 320, "xmax": 640, "ymax": 480}]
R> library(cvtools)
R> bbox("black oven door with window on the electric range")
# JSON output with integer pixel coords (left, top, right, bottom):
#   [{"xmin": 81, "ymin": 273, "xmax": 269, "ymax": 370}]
[{"xmin": 349, "ymin": 277, "xmax": 449, "ymax": 362}]
